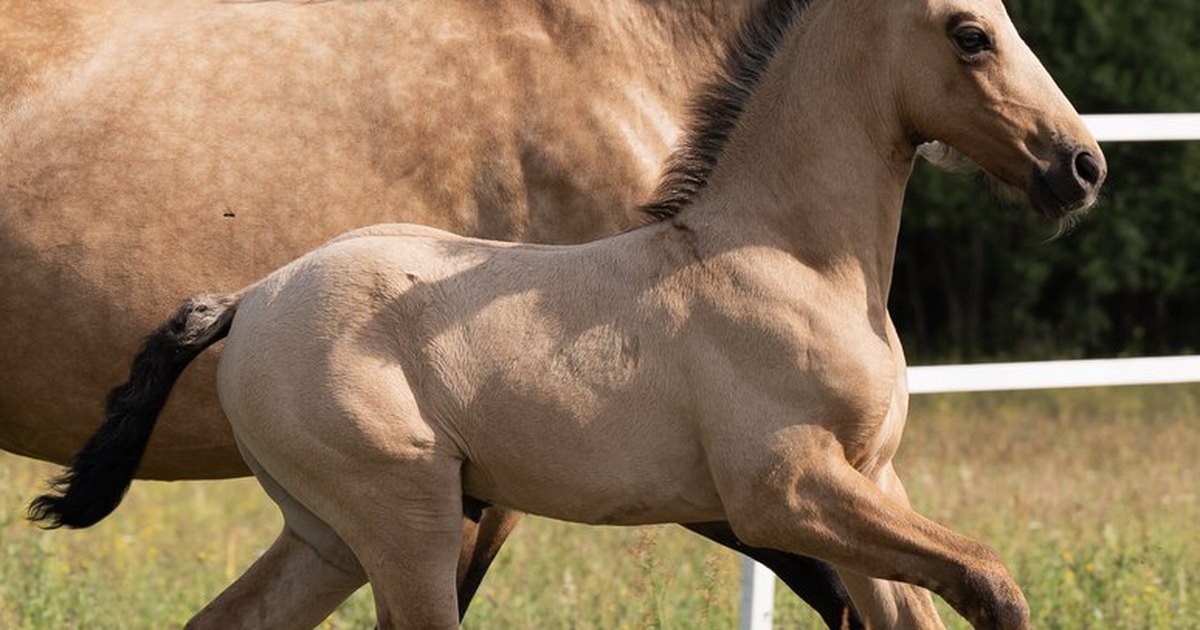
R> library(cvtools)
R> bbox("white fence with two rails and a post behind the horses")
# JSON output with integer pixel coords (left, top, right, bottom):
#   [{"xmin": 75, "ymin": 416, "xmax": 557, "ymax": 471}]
[{"xmin": 739, "ymin": 114, "xmax": 1200, "ymax": 630}]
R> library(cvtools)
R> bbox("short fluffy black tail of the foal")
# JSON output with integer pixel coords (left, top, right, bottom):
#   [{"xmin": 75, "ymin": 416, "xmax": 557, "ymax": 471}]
[{"xmin": 29, "ymin": 292, "xmax": 245, "ymax": 529}]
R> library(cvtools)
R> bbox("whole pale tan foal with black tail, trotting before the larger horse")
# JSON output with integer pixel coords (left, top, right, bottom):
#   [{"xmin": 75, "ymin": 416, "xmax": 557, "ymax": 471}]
[{"xmin": 35, "ymin": 0, "xmax": 1105, "ymax": 628}]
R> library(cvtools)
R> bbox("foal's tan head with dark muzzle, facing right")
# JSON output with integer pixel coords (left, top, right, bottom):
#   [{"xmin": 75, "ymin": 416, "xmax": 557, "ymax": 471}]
[{"xmin": 883, "ymin": 0, "xmax": 1106, "ymax": 218}]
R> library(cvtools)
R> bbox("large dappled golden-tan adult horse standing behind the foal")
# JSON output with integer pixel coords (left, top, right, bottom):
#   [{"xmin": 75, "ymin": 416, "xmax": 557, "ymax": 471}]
[{"xmin": 0, "ymin": 0, "xmax": 864, "ymax": 623}]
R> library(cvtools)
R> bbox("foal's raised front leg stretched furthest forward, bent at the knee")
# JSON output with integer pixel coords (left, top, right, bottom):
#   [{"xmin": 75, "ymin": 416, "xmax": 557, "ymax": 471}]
[{"xmin": 710, "ymin": 425, "xmax": 1028, "ymax": 630}]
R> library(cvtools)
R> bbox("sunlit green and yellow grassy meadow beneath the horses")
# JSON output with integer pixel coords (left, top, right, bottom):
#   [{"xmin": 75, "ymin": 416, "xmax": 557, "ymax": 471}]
[{"xmin": 0, "ymin": 386, "xmax": 1200, "ymax": 629}]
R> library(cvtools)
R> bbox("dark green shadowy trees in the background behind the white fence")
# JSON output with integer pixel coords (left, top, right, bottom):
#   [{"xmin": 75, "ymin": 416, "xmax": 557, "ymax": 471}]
[{"xmin": 892, "ymin": 0, "xmax": 1200, "ymax": 364}]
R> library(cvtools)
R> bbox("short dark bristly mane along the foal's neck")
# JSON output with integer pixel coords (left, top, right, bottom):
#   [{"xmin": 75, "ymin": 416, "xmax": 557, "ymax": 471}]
[{"xmin": 641, "ymin": 0, "xmax": 811, "ymax": 221}]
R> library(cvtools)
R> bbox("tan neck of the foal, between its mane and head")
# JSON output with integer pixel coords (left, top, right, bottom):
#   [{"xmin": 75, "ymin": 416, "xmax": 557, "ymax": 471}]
[{"xmin": 679, "ymin": 2, "xmax": 913, "ymax": 304}]
